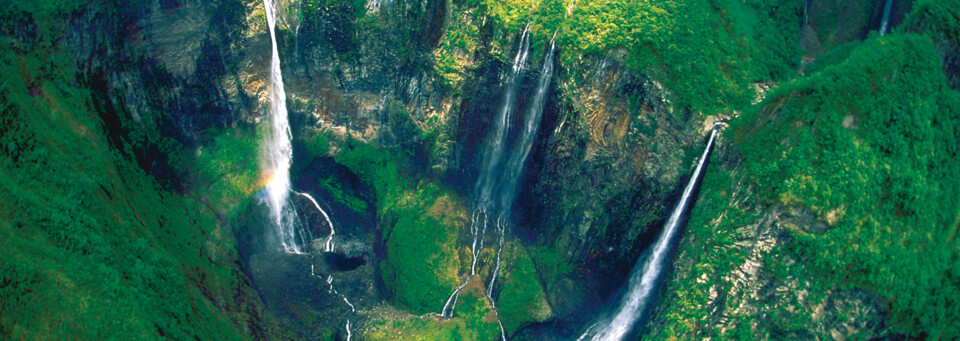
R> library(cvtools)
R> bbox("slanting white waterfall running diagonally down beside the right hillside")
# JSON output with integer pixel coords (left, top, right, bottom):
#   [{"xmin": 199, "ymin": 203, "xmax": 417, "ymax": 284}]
[{"xmin": 578, "ymin": 126, "xmax": 719, "ymax": 341}]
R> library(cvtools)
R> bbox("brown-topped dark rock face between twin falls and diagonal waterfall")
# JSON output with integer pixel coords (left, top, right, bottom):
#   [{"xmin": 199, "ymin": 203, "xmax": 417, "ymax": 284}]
[{"xmin": 515, "ymin": 56, "xmax": 705, "ymax": 317}]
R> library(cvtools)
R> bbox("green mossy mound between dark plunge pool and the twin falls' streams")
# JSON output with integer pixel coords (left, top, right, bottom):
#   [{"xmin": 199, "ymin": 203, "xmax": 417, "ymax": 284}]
[{"xmin": 311, "ymin": 134, "xmax": 466, "ymax": 314}]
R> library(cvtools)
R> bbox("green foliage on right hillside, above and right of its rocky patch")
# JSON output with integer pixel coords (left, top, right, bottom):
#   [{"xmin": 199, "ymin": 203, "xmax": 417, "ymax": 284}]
[{"xmin": 732, "ymin": 35, "xmax": 960, "ymax": 339}]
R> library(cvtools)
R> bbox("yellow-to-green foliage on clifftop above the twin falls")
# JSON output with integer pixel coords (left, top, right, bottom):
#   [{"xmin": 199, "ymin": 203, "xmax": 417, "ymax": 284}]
[{"xmin": 447, "ymin": 0, "xmax": 802, "ymax": 112}]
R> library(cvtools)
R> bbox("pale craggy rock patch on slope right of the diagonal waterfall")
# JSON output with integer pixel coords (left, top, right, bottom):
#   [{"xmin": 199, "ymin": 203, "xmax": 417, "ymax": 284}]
[{"xmin": 644, "ymin": 143, "xmax": 889, "ymax": 340}]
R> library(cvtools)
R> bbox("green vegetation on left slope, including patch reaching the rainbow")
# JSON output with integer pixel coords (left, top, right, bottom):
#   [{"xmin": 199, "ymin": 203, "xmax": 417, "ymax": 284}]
[{"xmin": 0, "ymin": 1, "xmax": 290, "ymax": 339}]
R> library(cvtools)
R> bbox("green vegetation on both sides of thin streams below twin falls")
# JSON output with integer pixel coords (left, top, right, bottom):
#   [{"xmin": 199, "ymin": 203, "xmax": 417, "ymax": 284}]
[{"xmin": 309, "ymin": 133, "xmax": 552, "ymax": 332}]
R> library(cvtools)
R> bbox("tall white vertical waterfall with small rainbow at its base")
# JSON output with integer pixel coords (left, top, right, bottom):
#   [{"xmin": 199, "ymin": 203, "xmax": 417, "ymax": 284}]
[{"xmin": 260, "ymin": 0, "xmax": 307, "ymax": 253}]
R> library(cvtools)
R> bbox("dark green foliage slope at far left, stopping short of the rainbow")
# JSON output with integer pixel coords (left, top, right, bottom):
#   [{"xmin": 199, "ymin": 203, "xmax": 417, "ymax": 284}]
[{"xmin": 0, "ymin": 10, "xmax": 251, "ymax": 339}]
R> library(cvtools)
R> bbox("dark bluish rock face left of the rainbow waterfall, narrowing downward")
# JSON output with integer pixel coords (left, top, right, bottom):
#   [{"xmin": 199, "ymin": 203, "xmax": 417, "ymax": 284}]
[{"xmin": 61, "ymin": 0, "xmax": 284, "ymax": 339}]
